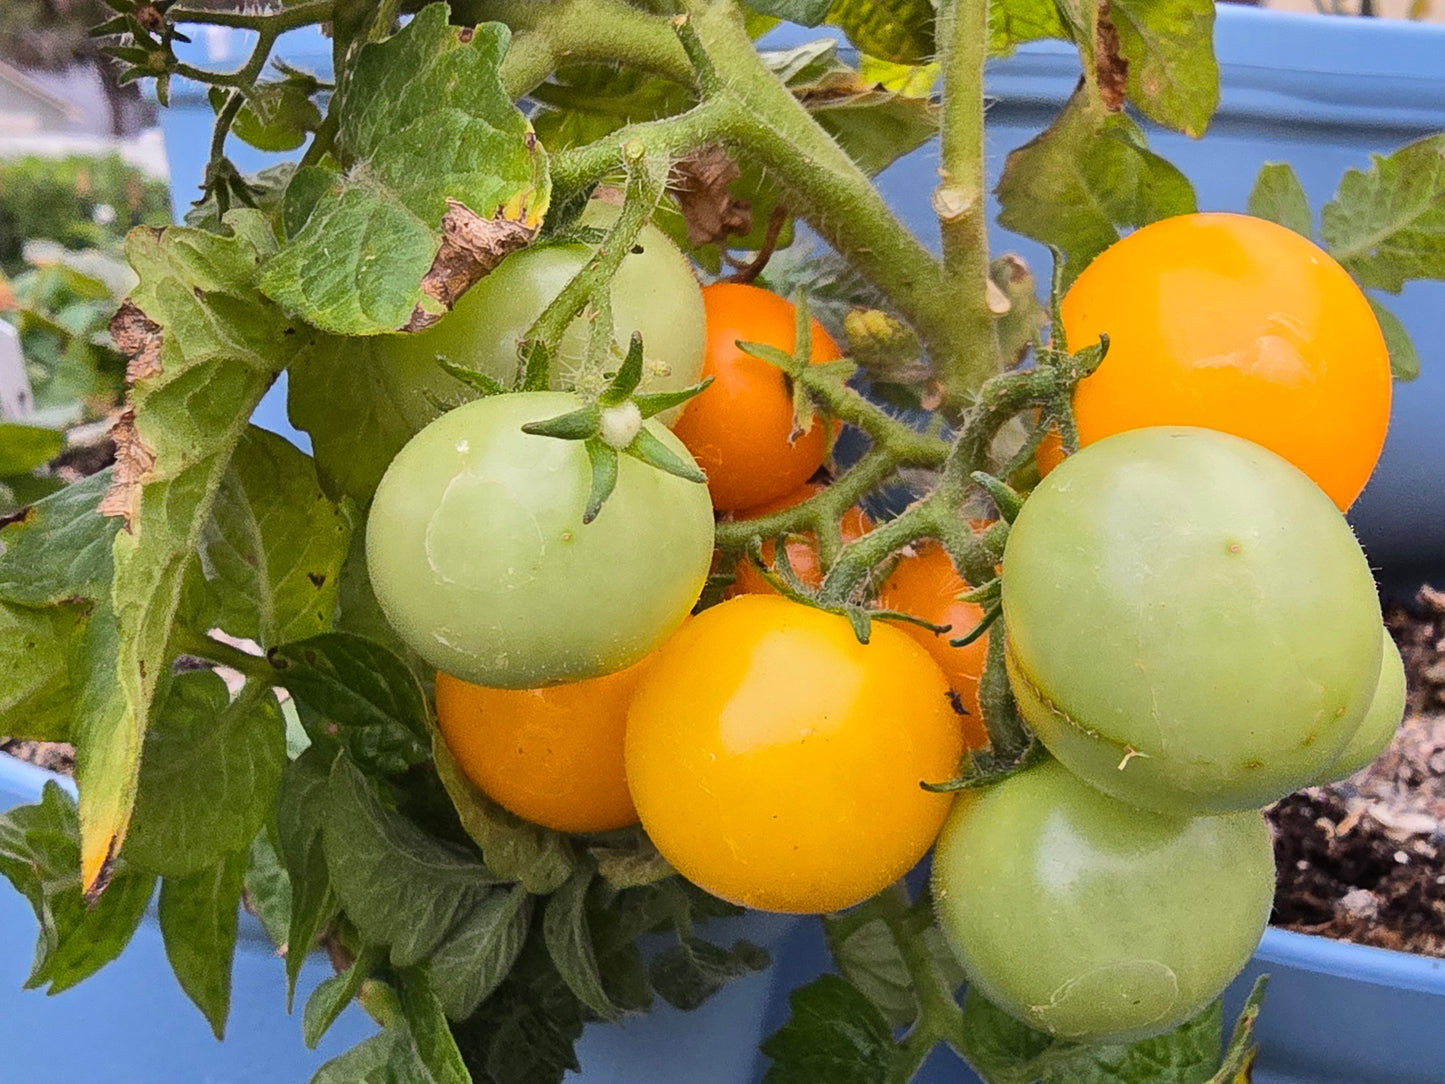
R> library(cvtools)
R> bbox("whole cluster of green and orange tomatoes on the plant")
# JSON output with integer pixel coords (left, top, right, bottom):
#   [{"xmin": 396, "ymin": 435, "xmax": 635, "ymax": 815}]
[{"xmin": 367, "ymin": 215, "xmax": 1403, "ymax": 1041}]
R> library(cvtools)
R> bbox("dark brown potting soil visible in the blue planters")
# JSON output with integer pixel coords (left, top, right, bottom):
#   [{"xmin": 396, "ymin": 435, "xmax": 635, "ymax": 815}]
[{"xmin": 0, "ymin": 587, "xmax": 1445, "ymax": 957}]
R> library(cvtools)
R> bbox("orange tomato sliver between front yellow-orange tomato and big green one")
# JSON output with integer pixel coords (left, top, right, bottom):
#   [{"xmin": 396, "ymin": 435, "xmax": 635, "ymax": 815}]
[{"xmin": 879, "ymin": 542, "xmax": 988, "ymax": 749}]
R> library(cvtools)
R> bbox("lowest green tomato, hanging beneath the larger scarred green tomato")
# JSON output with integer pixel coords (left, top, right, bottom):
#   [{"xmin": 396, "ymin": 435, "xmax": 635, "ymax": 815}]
[{"xmin": 933, "ymin": 762, "xmax": 1274, "ymax": 1042}]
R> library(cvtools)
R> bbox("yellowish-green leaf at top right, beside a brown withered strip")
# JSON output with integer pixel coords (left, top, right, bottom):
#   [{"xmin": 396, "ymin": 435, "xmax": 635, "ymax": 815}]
[{"xmin": 1108, "ymin": 0, "xmax": 1220, "ymax": 139}]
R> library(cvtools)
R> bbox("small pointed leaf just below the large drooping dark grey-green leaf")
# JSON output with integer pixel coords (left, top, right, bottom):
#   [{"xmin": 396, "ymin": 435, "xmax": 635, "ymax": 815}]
[{"xmin": 428, "ymin": 885, "xmax": 535, "ymax": 1020}]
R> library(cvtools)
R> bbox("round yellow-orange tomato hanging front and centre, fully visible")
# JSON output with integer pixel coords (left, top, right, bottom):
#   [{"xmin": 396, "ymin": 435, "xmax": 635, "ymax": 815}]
[{"xmin": 627, "ymin": 595, "xmax": 964, "ymax": 913}]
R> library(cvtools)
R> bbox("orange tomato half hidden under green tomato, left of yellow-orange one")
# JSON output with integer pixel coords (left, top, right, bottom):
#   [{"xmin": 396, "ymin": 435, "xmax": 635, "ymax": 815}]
[{"xmin": 436, "ymin": 667, "xmax": 650, "ymax": 833}]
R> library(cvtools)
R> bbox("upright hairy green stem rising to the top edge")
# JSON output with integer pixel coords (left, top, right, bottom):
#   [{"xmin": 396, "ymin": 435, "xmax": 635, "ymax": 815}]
[{"xmin": 933, "ymin": 0, "xmax": 998, "ymax": 415}]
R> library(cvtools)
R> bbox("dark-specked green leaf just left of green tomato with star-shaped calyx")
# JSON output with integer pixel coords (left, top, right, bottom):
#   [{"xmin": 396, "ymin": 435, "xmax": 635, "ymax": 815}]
[{"xmin": 182, "ymin": 426, "xmax": 351, "ymax": 648}]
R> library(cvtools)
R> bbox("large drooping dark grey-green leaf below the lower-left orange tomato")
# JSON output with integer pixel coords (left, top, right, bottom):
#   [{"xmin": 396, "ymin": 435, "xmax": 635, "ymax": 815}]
[{"xmin": 322, "ymin": 757, "xmax": 496, "ymax": 967}]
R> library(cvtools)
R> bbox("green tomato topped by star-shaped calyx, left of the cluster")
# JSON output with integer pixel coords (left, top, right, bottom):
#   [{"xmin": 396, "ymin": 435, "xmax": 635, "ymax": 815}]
[{"xmin": 366, "ymin": 392, "xmax": 712, "ymax": 688}]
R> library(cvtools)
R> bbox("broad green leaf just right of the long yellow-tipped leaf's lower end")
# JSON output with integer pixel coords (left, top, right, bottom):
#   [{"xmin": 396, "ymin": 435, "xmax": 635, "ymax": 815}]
[{"xmin": 126, "ymin": 671, "xmax": 286, "ymax": 877}]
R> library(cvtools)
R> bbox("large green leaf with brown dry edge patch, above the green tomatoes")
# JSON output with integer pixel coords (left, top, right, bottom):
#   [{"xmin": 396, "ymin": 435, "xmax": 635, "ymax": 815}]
[{"xmin": 262, "ymin": 3, "xmax": 551, "ymax": 335}]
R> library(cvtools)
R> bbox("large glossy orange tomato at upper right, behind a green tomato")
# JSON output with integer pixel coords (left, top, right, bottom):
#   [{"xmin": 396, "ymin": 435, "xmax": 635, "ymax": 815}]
[{"xmin": 1062, "ymin": 214, "xmax": 1390, "ymax": 509}]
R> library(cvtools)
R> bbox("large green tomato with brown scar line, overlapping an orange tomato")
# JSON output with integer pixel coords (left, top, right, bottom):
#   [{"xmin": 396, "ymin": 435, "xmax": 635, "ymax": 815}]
[{"xmin": 1003, "ymin": 428, "xmax": 1381, "ymax": 815}]
